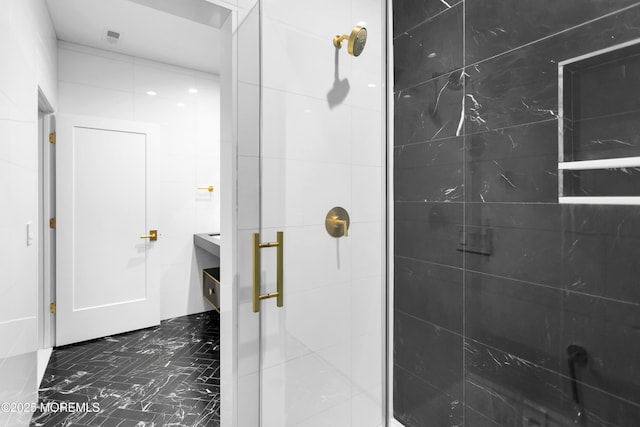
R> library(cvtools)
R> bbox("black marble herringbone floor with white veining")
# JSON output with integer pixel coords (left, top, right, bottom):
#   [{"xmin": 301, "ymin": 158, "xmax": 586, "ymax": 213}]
[{"xmin": 31, "ymin": 311, "xmax": 220, "ymax": 427}]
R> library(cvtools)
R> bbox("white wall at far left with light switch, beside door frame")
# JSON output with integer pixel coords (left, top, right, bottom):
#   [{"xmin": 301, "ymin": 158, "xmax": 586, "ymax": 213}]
[{"xmin": 0, "ymin": 0, "xmax": 57, "ymax": 426}]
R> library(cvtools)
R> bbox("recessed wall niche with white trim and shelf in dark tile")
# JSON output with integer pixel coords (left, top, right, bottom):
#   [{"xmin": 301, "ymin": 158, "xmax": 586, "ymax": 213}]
[{"xmin": 558, "ymin": 39, "xmax": 640, "ymax": 204}]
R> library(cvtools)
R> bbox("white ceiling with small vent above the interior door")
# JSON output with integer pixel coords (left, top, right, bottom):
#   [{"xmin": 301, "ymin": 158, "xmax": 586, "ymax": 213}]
[{"xmin": 47, "ymin": 0, "xmax": 229, "ymax": 74}]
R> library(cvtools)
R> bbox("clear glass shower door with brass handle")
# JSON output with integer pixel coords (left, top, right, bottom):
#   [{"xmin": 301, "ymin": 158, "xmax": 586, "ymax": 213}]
[{"xmin": 249, "ymin": 0, "xmax": 386, "ymax": 427}]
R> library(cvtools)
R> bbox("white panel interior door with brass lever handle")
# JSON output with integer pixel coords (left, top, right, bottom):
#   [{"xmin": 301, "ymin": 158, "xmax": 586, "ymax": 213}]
[{"xmin": 56, "ymin": 115, "xmax": 160, "ymax": 346}]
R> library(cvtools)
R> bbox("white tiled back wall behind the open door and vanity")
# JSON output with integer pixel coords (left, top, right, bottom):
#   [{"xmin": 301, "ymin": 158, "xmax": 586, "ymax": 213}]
[{"xmin": 58, "ymin": 42, "xmax": 220, "ymax": 319}]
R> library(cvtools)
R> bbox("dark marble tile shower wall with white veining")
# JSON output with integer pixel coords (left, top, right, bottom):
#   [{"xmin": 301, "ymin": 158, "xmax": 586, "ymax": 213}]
[{"xmin": 393, "ymin": 0, "xmax": 640, "ymax": 427}]
